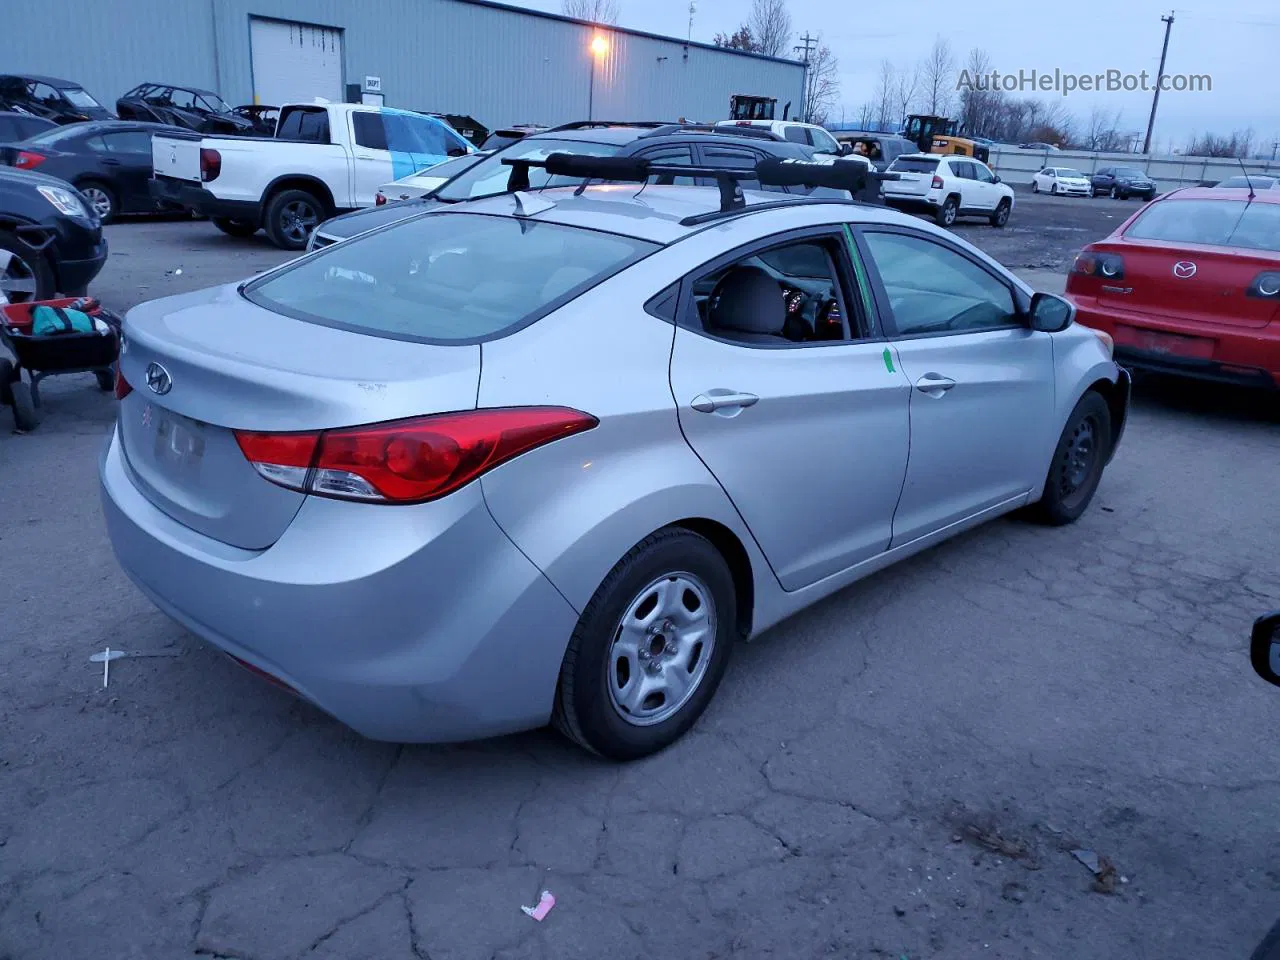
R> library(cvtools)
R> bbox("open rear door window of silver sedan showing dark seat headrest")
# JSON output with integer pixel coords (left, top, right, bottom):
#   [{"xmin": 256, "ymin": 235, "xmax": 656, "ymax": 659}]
[{"xmin": 692, "ymin": 241, "xmax": 846, "ymax": 346}]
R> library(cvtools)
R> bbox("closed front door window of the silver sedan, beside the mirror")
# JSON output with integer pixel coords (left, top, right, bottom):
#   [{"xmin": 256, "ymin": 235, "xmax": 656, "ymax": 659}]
[{"xmin": 864, "ymin": 232, "xmax": 1020, "ymax": 337}]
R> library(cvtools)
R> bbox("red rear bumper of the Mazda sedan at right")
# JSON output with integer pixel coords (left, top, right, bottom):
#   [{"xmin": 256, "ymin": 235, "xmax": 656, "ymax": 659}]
[{"xmin": 1068, "ymin": 300, "xmax": 1280, "ymax": 389}]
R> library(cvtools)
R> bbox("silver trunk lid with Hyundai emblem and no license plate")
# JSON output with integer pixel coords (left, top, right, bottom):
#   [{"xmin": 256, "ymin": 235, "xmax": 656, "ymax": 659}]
[{"xmin": 119, "ymin": 285, "xmax": 480, "ymax": 549}]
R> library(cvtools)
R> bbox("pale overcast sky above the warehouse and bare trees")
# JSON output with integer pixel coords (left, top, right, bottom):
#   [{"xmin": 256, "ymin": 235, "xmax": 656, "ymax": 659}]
[{"xmin": 515, "ymin": 0, "xmax": 1280, "ymax": 154}]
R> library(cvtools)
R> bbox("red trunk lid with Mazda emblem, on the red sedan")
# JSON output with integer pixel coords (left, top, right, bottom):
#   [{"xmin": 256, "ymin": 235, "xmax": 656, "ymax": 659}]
[{"xmin": 1091, "ymin": 239, "xmax": 1280, "ymax": 329}]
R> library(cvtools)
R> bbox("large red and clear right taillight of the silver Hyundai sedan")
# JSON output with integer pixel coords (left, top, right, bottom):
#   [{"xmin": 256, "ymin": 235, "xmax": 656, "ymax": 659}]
[{"xmin": 236, "ymin": 407, "xmax": 599, "ymax": 503}]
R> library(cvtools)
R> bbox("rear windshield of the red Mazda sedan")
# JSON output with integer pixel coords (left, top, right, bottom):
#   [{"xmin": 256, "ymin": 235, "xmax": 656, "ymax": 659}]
[{"xmin": 1124, "ymin": 200, "xmax": 1280, "ymax": 252}]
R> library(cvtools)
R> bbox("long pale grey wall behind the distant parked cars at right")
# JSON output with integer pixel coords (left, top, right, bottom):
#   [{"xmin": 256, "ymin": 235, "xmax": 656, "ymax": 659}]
[{"xmin": 991, "ymin": 147, "xmax": 1280, "ymax": 193}]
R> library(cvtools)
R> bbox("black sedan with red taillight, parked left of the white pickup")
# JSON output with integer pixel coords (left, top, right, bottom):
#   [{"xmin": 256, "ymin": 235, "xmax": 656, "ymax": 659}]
[{"xmin": 0, "ymin": 120, "xmax": 172, "ymax": 223}]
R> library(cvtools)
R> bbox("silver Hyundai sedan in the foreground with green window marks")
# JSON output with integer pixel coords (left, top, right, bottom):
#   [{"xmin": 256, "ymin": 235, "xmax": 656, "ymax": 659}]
[{"xmin": 101, "ymin": 184, "xmax": 1129, "ymax": 759}]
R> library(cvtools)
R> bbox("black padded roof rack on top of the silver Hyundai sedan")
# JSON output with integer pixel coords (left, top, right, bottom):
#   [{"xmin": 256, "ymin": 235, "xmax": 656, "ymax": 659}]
[{"xmin": 502, "ymin": 154, "xmax": 899, "ymax": 227}]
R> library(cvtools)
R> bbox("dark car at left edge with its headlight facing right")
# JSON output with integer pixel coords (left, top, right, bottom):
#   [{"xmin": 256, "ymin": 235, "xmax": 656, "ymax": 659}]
[{"xmin": 0, "ymin": 166, "xmax": 106, "ymax": 303}]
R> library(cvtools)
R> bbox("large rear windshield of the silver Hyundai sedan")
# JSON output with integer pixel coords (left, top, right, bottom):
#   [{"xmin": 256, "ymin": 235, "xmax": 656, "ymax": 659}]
[{"xmin": 244, "ymin": 211, "xmax": 658, "ymax": 343}]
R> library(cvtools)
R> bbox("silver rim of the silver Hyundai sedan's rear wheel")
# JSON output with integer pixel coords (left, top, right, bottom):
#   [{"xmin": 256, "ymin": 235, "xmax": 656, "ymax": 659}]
[{"xmin": 605, "ymin": 572, "xmax": 716, "ymax": 727}]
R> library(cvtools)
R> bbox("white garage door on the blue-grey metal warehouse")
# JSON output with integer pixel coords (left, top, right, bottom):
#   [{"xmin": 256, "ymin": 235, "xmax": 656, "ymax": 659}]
[{"xmin": 250, "ymin": 18, "xmax": 344, "ymax": 106}]
